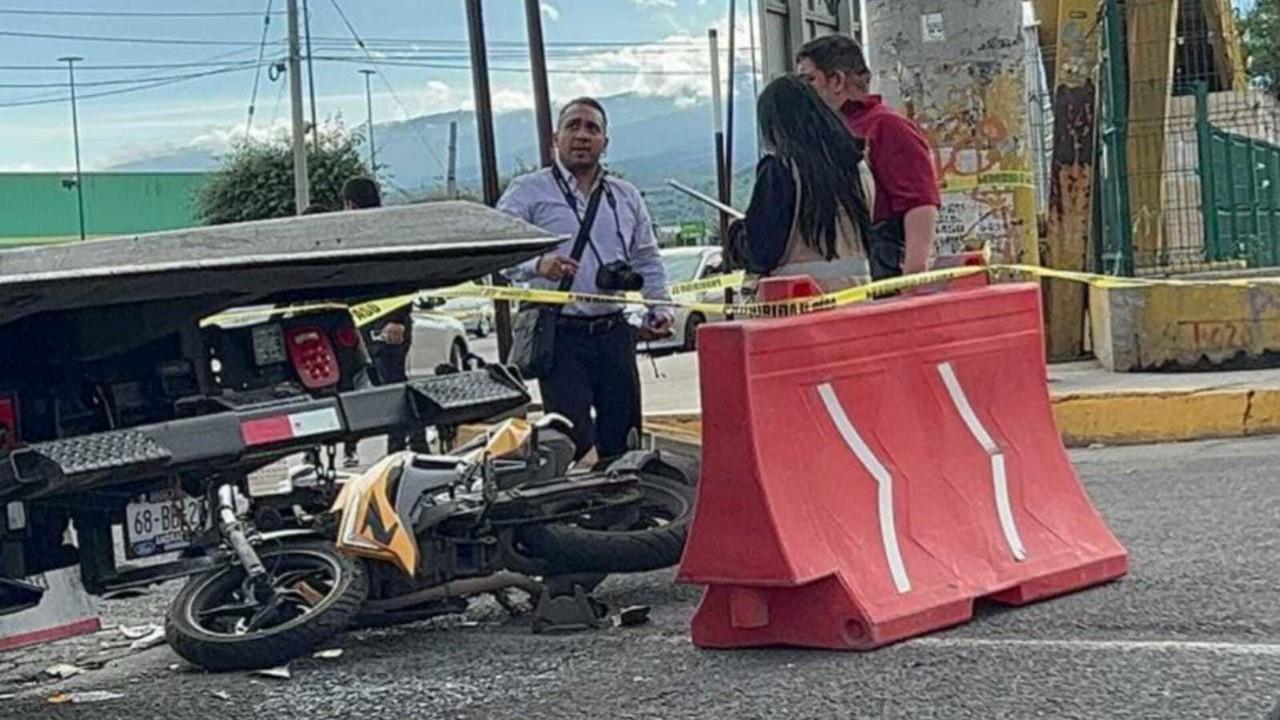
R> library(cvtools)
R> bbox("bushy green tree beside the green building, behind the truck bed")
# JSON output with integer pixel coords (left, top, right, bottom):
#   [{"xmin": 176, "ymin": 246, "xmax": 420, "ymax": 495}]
[{"xmin": 196, "ymin": 126, "xmax": 370, "ymax": 225}]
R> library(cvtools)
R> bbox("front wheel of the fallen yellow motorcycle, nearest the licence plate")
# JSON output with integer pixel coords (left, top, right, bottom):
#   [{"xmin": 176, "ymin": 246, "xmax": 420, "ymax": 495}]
[{"xmin": 165, "ymin": 541, "xmax": 369, "ymax": 670}]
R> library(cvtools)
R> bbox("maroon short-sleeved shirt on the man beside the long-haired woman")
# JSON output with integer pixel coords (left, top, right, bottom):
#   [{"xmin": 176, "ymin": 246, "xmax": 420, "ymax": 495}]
[{"xmin": 841, "ymin": 95, "xmax": 942, "ymax": 223}]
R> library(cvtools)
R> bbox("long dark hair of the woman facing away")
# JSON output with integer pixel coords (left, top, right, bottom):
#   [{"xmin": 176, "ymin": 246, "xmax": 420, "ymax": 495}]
[{"xmin": 756, "ymin": 76, "xmax": 870, "ymax": 260}]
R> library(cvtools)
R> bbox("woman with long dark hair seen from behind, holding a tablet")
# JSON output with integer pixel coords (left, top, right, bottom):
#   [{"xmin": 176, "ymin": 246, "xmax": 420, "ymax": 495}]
[{"xmin": 730, "ymin": 76, "xmax": 874, "ymax": 292}]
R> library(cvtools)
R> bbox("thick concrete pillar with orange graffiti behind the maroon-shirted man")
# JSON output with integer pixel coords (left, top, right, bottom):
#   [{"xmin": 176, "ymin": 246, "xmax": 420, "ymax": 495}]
[{"xmin": 865, "ymin": 0, "xmax": 1039, "ymax": 264}]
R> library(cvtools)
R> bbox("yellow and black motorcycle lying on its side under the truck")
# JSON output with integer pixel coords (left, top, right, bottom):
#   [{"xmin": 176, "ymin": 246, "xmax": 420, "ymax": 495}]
[{"xmin": 165, "ymin": 415, "xmax": 698, "ymax": 670}]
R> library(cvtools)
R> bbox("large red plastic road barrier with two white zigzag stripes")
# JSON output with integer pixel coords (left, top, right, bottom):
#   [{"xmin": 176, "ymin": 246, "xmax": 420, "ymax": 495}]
[{"xmin": 678, "ymin": 283, "xmax": 1128, "ymax": 650}]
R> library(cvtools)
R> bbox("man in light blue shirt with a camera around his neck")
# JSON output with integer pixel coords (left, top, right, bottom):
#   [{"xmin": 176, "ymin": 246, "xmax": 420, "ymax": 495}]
[{"xmin": 498, "ymin": 97, "xmax": 675, "ymax": 460}]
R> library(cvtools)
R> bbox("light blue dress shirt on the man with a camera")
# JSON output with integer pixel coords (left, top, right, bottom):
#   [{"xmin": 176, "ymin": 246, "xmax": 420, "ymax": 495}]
[{"xmin": 498, "ymin": 161, "xmax": 675, "ymax": 320}]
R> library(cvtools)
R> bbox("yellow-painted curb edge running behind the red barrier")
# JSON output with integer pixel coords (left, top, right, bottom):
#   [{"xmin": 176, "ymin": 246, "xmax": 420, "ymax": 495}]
[{"xmin": 645, "ymin": 387, "xmax": 1280, "ymax": 447}]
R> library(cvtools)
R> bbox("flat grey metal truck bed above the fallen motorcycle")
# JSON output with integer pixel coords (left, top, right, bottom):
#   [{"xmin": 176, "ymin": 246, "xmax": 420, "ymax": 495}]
[{"xmin": 0, "ymin": 202, "xmax": 558, "ymax": 334}]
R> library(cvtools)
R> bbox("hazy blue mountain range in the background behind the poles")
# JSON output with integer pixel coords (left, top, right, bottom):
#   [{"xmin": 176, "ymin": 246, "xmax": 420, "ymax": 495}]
[{"xmin": 110, "ymin": 94, "xmax": 756, "ymax": 224}]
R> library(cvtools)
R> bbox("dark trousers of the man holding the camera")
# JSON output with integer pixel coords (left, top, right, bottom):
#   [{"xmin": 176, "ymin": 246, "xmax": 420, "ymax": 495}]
[{"xmin": 539, "ymin": 313, "xmax": 641, "ymax": 460}]
